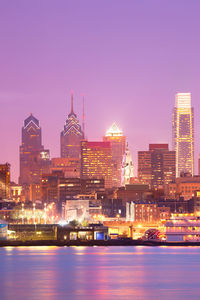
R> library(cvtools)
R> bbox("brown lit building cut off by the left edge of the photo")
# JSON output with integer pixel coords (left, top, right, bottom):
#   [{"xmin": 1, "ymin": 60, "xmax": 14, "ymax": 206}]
[{"xmin": 0, "ymin": 163, "xmax": 10, "ymax": 199}]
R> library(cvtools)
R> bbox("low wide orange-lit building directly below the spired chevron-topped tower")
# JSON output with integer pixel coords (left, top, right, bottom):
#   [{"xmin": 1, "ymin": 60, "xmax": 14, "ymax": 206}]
[{"xmin": 51, "ymin": 157, "xmax": 81, "ymax": 178}]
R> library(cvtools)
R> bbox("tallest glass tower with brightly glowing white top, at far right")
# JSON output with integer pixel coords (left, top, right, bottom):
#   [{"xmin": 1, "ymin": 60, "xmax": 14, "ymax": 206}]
[{"xmin": 172, "ymin": 93, "xmax": 194, "ymax": 177}]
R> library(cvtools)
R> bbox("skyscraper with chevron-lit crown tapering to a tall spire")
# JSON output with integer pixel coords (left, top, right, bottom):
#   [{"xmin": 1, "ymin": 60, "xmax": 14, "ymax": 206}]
[{"xmin": 60, "ymin": 94, "xmax": 83, "ymax": 159}]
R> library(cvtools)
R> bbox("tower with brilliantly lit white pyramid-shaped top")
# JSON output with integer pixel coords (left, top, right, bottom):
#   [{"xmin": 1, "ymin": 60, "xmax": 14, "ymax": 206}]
[{"xmin": 103, "ymin": 123, "xmax": 126, "ymax": 187}]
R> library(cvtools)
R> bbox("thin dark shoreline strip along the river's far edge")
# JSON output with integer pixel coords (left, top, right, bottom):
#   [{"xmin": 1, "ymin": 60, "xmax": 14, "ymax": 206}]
[{"xmin": 0, "ymin": 240, "xmax": 200, "ymax": 247}]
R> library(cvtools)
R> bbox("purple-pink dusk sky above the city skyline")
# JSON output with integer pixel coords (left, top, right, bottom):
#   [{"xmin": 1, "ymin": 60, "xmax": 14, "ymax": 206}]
[{"xmin": 0, "ymin": 0, "xmax": 200, "ymax": 180}]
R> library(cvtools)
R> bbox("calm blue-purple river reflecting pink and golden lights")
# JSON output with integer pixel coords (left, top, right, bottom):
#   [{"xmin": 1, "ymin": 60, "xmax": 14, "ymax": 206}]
[{"xmin": 0, "ymin": 247, "xmax": 200, "ymax": 300}]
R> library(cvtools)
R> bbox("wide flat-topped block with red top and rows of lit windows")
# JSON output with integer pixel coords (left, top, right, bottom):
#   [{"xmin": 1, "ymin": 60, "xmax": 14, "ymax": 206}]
[{"xmin": 81, "ymin": 140, "xmax": 112, "ymax": 188}]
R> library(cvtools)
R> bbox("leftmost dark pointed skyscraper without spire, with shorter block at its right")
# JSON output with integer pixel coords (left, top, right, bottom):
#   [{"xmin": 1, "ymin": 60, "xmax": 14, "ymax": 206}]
[{"xmin": 19, "ymin": 114, "xmax": 50, "ymax": 185}]
